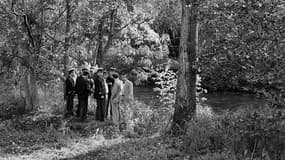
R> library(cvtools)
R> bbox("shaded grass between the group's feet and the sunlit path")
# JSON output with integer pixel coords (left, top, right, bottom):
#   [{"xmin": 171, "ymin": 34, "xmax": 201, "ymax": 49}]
[{"xmin": 0, "ymin": 114, "xmax": 120, "ymax": 156}]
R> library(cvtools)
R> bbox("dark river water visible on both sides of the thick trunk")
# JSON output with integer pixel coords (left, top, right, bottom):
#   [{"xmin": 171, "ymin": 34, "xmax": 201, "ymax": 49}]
[{"xmin": 134, "ymin": 87, "xmax": 265, "ymax": 114}]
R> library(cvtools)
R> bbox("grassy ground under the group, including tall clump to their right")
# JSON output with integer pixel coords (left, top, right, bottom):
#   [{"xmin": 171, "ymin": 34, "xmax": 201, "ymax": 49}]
[{"xmin": 0, "ymin": 98, "xmax": 171, "ymax": 159}]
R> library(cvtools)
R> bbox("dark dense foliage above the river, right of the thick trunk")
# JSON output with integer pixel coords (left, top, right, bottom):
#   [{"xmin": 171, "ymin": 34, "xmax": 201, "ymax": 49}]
[{"xmin": 199, "ymin": 0, "xmax": 284, "ymax": 92}]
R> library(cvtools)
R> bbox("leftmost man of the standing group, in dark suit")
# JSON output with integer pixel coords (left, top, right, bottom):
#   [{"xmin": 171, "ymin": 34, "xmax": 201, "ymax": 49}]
[{"xmin": 64, "ymin": 68, "xmax": 76, "ymax": 116}]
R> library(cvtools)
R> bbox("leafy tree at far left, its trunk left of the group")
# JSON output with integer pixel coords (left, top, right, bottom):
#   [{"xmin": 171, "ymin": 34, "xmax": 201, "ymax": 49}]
[{"xmin": 0, "ymin": 0, "xmax": 67, "ymax": 110}]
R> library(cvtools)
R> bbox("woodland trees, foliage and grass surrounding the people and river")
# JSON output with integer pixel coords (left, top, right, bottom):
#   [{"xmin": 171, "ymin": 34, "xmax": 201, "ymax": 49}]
[{"xmin": 0, "ymin": 0, "xmax": 285, "ymax": 160}]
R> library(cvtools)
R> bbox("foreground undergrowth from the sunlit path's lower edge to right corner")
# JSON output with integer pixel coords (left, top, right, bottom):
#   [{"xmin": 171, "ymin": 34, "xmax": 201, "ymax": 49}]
[{"xmin": 60, "ymin": 104, "xmax": 285, "ymax": 160}]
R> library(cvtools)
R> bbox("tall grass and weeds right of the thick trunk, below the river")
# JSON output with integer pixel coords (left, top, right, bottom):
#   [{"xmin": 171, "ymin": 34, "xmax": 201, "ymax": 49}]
[{"xmin": 181, "ymin": 107, "xmax": 285, "ymax": 160}]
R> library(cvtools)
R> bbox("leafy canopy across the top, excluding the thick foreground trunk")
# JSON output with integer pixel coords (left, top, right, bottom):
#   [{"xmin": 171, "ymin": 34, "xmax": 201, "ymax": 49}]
[{"xmin": 0, "ymin": 0, "xmax": 285, "ymax": 92}]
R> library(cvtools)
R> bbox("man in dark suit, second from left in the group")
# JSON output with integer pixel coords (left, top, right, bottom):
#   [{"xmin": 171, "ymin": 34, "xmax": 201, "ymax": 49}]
[{"xmin": 75, "ymin": 69, "xmax": 91, "ymax": 121}]
